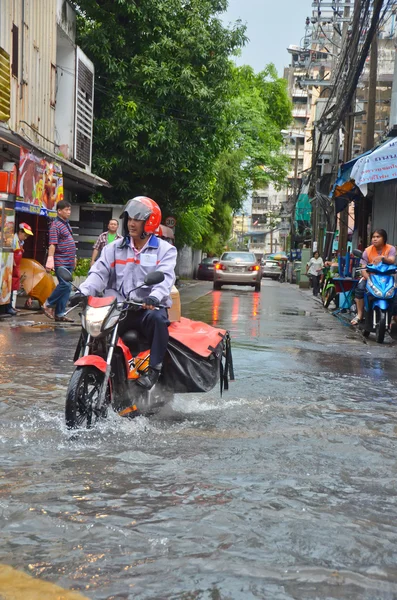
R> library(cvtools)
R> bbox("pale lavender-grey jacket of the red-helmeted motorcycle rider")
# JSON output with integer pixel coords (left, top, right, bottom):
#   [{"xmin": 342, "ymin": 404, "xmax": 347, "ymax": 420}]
[{"xmin": 80, "ymin": 235, "xmax": 177, "ymax": 308}]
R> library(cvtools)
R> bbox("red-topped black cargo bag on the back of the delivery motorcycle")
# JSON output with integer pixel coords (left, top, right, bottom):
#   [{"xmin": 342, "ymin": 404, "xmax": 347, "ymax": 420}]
[{"xmin": 163, "ymin": 317, "xmax": 234, "ymax": 393}]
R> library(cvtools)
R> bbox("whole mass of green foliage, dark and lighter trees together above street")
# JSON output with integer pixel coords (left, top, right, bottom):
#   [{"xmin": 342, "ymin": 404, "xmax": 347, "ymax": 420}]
[{"xmin": 75, "ymin": 0, "xmax": 290, "ymax": 248}]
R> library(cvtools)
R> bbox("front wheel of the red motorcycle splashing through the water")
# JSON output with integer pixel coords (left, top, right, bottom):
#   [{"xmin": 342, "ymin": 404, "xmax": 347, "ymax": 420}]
[{"xmin": 65, "ymin": 367, "xmax": 112, "ymax": 429}]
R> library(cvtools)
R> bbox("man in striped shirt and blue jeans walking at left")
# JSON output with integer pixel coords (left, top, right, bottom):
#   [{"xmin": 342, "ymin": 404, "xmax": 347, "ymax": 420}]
[{"xmin": 42, "ymin": 200, "xmax": 76, "ymax": 323}]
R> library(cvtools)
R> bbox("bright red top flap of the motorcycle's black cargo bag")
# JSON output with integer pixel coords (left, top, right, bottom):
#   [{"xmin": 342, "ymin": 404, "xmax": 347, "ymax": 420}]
[{"xmin": 168, "ymin": 317, "xmax": 226, "ymax": 358}]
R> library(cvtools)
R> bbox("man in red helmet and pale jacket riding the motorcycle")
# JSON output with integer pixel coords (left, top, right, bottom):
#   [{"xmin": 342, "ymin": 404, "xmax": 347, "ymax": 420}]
[{"xmin": 70, "ymin": 196, "xmax": 177, "ymax": 390}]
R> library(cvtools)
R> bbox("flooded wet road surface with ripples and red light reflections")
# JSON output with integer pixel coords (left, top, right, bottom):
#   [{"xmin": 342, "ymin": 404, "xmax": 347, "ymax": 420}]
[{"xmin": 0, "ymin": 281, "xmax": 397, "ymax": 600}]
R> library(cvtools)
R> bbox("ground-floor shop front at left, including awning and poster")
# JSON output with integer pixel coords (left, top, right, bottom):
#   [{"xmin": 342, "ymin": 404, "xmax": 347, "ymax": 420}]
[{"xmin": 0, "ymin": 123, "xmax": 110, "ymax": 313}]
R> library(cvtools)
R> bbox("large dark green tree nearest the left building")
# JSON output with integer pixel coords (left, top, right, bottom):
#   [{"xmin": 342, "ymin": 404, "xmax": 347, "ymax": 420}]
[{"xmin": 71, "ymin": 0, "xmax": 244, "ymax": 223}]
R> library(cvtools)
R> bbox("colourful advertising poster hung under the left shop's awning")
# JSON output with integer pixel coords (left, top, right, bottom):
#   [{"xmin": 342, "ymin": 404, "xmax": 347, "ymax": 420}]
[{"xmin": 15, "ymin": 147, "xmax": 63, "ymax": 217}]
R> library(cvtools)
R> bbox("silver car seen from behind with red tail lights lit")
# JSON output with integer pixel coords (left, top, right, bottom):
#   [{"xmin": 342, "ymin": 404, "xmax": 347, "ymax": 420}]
[{"xmin": 214, "ymin": 252, "xmax": 262, "ymax": 292}]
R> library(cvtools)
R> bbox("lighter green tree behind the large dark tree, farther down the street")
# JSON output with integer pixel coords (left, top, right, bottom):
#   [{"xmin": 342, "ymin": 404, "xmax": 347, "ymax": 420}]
[{"xmin": 203, "ymin": 64, "xmax": 292, "ymax": 249}]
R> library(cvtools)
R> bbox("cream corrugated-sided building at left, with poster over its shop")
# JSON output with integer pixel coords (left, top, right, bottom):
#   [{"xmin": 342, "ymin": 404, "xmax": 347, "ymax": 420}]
[{"xmin": 0, "ymin": 0, "xmax": 108, "ymax": 262}]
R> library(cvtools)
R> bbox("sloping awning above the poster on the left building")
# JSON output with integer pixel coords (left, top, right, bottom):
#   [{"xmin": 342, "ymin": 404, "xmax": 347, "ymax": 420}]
[{"xmin": 0, "ymin": 123, "xmax": 111, "ymax": 192}]
